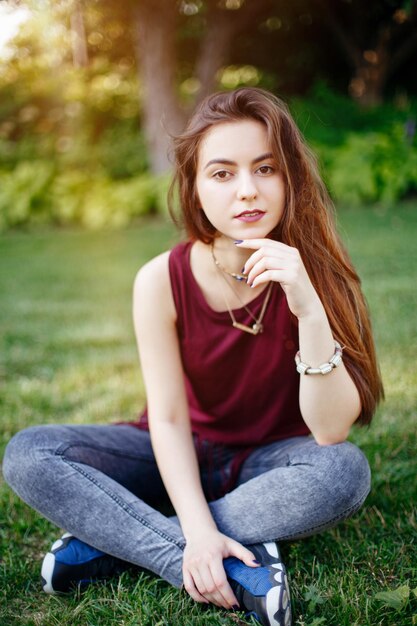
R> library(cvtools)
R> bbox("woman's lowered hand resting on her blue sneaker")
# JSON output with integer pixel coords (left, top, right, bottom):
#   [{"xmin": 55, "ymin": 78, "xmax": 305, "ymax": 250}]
[{"xmin": 182, "ymin": 529, "xmax": 258, "ymax": 609}]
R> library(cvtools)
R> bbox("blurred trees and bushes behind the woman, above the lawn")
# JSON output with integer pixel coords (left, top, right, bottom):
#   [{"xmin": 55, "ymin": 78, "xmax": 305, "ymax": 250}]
[{"xmin": 0, "ymin": 0, "xmax": 417, "ymax": 231}]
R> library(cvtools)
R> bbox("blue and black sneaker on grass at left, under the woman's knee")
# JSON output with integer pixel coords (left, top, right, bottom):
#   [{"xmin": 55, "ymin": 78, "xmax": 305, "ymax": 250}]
[{"xmin": 41, "ymin": 533, "xmax": 132, "ymax": 594}]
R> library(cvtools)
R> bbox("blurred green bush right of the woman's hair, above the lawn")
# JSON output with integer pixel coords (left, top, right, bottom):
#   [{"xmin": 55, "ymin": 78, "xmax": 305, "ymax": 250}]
[{"xmin": 290, "ymin": 83, "xmax": 417, "ymax": 205}]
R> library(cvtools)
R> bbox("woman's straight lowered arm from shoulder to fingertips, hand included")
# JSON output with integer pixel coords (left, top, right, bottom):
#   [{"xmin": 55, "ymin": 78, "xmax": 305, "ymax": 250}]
[{"xmin": 133, "ymin": 253, "xmax": 255, "ymax": 608}]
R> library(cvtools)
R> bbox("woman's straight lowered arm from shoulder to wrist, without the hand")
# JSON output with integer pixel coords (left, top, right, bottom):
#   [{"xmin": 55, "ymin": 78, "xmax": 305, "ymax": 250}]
[{"xmin": 133, "ymin": 255, "xmax": 214, "ymax": 533}]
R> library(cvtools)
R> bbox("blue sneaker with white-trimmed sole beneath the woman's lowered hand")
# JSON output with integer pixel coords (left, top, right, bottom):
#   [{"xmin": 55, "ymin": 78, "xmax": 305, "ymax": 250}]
[{"xmin": 223, "ymin": 542, "xmax": 292, "ymax": 626}]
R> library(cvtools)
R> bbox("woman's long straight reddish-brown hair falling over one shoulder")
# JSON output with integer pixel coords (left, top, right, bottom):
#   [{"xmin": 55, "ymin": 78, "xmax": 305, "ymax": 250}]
[{"xmin": 169, "ymin": 87, "xmax": 384, "ymax": 424}]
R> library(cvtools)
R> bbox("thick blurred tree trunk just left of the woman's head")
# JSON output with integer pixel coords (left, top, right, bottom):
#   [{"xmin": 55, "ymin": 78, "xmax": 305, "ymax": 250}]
[{"xmin": 133, "ymin": 0, "xmax": 185, "ymax": 174}]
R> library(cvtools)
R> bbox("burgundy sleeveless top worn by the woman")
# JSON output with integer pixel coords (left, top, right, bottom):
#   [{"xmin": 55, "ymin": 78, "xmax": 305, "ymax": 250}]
[{"xmin": 136, "ymin": 236, "xmax": 310, "ymax": 449}]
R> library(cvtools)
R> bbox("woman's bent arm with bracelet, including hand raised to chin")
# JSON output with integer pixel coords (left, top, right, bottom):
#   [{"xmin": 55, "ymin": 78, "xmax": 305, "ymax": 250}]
[{"xmin": 239, "ymin": 239, "xmax": 361, "ymax": 445}]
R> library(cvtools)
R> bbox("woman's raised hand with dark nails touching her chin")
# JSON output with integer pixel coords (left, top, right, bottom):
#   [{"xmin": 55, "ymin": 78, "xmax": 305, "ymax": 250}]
[{"xmin": 236, "ymin": 239, "xmax": 322, "ymax": 319}]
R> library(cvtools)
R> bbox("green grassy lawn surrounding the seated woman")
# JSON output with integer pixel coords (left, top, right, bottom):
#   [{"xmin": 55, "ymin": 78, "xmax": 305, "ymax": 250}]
[{"xmin": 0, "ymin": 205, "xmax": 417, "ymax": 626}]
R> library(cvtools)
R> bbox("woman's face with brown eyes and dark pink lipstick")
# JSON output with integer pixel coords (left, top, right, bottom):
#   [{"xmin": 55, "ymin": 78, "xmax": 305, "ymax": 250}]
[{"xmin": 196, "ymin": 119, "xmax": 285, "ymax": 239}]
